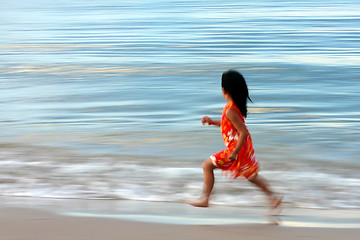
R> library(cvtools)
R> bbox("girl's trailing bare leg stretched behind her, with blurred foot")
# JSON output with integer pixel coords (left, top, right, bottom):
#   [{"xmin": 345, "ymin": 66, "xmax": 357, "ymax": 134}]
[{"xmin": 249, "ymin": 175, "xmax": 282, "ymax": 215}]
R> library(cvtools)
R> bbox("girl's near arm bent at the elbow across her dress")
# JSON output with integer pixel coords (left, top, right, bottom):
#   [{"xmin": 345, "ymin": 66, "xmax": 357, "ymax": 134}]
[{"xmin": 226, "ymin": 108, "xmax": 249, "ymax": 161}]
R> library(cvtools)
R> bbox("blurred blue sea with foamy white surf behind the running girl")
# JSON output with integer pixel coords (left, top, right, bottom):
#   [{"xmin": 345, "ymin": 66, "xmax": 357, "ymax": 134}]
[{"xmin": 0, "ymin": 0, "xmax": 360, "ymax": 209}]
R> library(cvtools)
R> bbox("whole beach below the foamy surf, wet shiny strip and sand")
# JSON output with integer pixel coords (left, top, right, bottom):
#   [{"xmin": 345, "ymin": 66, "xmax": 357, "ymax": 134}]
[{"xmin": 0, "ymin": 201, "xmax": 360, "ymax": 240}]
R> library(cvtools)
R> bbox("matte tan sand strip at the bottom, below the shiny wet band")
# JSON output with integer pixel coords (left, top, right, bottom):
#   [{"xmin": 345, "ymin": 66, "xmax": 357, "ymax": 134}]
[{"xmin": 0, "ymin": 204, "xmax": 360, "ymax": 240}]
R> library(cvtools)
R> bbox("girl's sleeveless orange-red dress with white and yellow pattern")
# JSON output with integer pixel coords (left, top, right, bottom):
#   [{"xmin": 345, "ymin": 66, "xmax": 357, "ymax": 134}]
[{"xmin": 210, "ymin": 102, "xmax": 259, "ymax": 180}]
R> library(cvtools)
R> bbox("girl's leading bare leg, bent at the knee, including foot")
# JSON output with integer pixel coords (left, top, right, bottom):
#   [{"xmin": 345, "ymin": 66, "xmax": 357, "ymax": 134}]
[{"xmin": 187, "ymin": 158, "xmax": 216, "ymax": 207}]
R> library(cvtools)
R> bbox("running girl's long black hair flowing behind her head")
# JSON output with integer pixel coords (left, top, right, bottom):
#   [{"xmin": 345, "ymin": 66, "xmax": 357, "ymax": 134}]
[{"xmin": 221, "ymin": 70, "xmax": 252, "ymax": 118}]
